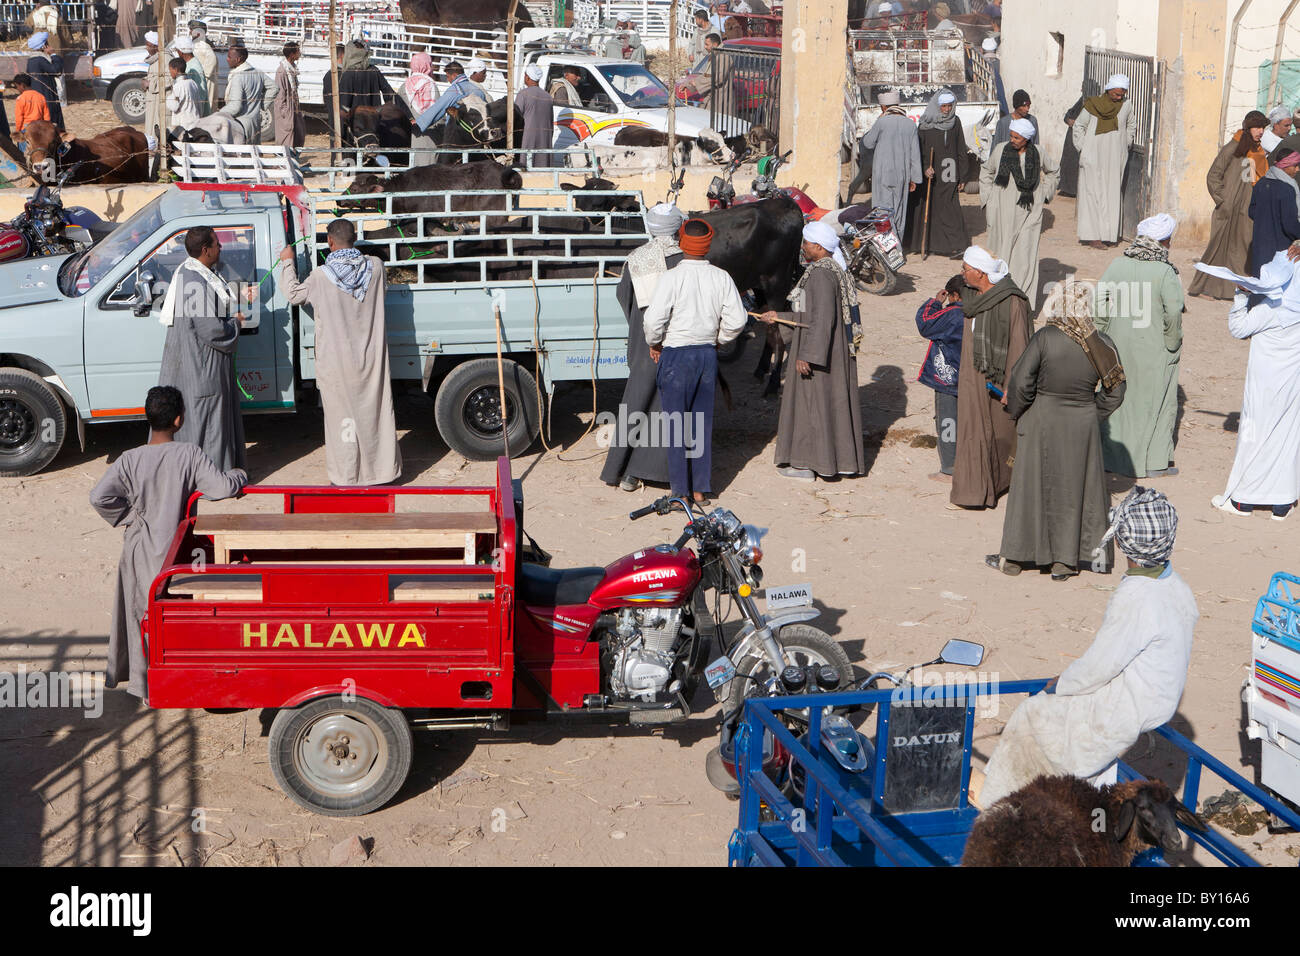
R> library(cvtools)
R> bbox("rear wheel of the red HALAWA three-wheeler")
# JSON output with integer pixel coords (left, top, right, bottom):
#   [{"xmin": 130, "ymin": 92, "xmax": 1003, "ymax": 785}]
[{"xmin": 268, "ymin": 695, "xmax": 412, "ymax": 817}]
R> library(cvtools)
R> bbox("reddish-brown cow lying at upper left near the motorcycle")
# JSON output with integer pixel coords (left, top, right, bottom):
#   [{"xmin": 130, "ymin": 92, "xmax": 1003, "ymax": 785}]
[{"xmin": 18, "ymin": 120, "xmax": 150, "ymax": 186}]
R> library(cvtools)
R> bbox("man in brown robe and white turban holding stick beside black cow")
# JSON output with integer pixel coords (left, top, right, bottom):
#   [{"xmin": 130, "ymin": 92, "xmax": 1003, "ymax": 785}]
[{"xmin": 761, "ymin": 222, "xmax": 867, "ymax": 481}]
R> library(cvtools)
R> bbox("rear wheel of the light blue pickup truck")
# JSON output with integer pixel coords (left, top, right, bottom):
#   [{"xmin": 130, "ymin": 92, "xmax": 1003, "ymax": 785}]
[{"xmin": 433, "ymin": 359, "xmax": 541, "ymax": 462}]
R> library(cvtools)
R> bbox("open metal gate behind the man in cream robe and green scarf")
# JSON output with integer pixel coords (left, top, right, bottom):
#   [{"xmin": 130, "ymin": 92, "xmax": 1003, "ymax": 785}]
[{"xmin": 1071, "ymin": 47, "xmax": 1165, "ymax": 238}]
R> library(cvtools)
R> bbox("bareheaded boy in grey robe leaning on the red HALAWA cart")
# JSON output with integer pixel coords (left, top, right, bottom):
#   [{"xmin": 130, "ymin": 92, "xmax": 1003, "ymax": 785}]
[{"xmin": 90, "ymin": 385, "xmax": 248, "ymax": 697}]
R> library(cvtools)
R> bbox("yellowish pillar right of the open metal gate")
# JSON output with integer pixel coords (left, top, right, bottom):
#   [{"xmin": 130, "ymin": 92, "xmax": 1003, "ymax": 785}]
[{"xmin": 1153, "ymin": 0, "xmax": 1227, "ymax": 239}]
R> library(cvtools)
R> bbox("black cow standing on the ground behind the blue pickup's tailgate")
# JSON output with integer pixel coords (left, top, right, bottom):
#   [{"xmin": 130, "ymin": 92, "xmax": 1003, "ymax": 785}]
[{"xmin": 701, "ymin": 196, "xmax": 803, "ymax": 395}]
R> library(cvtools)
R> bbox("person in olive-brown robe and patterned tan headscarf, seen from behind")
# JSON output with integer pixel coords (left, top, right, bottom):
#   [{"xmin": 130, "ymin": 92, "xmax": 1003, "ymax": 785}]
[{"xmin": 987, "ymin": 282, "xmax": 1125, "ymax": 581}]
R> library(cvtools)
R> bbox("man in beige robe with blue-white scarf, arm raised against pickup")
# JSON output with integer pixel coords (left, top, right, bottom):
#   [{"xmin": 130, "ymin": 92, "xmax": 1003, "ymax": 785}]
[{"xmin": 280, "ymin": 219, "xmax": 402, "ymax": 485}]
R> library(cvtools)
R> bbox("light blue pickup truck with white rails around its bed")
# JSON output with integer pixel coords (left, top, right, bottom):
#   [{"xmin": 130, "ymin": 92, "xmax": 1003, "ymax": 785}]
[{"xmin": 0, "ymin": 183, "xmax": 647, "ymax": 476}]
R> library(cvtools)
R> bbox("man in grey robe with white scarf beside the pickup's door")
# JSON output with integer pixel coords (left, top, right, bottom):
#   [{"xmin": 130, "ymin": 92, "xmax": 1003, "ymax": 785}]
[{"xmin": 159, "ymin": 226, "xmax": 244, "ymax": 471}]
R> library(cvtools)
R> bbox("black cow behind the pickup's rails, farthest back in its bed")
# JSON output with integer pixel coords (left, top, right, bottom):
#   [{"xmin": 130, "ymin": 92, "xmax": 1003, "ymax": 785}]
[{"xmin": 348, "ymin": 160, "xmax": 524, "ymax": 232}]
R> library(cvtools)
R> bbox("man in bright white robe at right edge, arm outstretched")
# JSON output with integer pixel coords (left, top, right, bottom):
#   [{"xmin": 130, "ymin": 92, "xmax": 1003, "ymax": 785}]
[{"xmin": 1196, "ymin": 251, "xmax": 1300, "ymax": 522}]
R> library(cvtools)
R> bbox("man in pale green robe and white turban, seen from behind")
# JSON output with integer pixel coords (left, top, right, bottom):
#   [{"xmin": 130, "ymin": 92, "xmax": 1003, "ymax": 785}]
[{"xmin": 1096, "ymin": 213, "xmax": 1183, "ymax": 479}]
